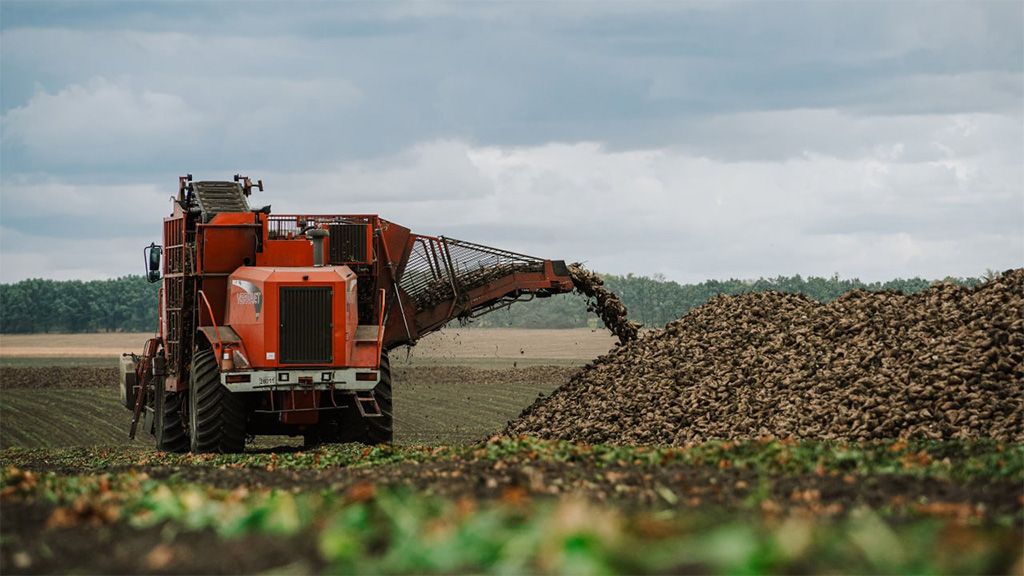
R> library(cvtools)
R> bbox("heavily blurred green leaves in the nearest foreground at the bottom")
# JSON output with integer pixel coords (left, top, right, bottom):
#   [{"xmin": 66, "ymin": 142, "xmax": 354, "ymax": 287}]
[{"xmin": 2, "ymin": 469, "xmax": 1019, "ymax": 574}]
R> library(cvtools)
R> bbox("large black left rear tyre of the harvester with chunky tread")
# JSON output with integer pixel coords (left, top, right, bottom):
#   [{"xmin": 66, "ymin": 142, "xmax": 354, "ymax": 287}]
[{"xmin": 188, "ymin": 349, "xmax": 246, "ymax": 453}]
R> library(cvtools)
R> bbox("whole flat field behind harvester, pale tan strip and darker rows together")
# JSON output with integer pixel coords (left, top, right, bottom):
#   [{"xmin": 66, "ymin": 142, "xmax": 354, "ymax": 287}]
[{"xmin": 0, "ymin": 329, "xmax": 602, "ymax": 448}]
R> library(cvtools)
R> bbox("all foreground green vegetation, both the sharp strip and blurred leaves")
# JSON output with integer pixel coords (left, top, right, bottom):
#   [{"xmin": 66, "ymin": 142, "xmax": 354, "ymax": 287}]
[{"xmin": 0, "ymin": 438, "xmax": 1024, "ymax": 574}]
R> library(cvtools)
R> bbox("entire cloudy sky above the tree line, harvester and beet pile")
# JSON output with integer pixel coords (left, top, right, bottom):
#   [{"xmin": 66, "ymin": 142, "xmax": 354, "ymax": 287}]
[{"xmin": 0, "ymin": 0, "xmax": 1024, "ymax": 282}]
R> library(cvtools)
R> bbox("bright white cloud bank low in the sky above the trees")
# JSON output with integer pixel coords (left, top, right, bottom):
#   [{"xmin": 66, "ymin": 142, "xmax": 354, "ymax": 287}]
[{"xmin": 0, "ymin": 136, "xmax": 1024, "ymax": 281}]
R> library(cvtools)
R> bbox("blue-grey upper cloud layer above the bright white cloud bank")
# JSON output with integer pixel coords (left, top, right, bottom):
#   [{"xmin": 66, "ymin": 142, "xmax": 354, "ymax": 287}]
[{"xmin": 0, "ymin": 3, "xmax": 1024, "ymax": 172}]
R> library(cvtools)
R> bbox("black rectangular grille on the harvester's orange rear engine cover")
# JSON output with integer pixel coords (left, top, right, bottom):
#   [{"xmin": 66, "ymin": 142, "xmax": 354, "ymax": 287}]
[{"xmin": 280, "ymin": 286, "xmax": 333, "ymax": 364}]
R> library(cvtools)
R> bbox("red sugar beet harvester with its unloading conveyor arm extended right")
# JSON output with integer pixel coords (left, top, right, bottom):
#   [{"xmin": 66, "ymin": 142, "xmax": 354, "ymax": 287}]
[{"xmin": 121, "ymin": 175, "xmax": 572, "ymax": 452}]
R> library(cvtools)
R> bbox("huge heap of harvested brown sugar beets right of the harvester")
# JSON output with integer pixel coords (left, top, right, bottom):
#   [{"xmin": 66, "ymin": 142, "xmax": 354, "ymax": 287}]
[{"xmin": 506, "ymin": 269, "xmax": 1024, "ymax": 445}]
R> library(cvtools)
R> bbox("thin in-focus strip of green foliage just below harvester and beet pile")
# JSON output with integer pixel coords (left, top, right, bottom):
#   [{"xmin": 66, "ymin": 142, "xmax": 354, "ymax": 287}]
[{"xmin": 0, "ymin": 437, "xmax": 1024, "ymax": 482}]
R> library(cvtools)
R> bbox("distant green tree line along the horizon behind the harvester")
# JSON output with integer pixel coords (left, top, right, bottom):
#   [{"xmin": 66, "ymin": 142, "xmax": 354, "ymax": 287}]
[{"xmin": 0, "ymin": 274, "xmax": 984, "ymax": 333}]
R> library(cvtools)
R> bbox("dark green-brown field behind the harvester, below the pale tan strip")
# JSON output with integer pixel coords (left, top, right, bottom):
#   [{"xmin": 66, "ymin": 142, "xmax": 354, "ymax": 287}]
[{"xmin": 0, "ymin": 365, "xmax": 577, "ymax": 448}]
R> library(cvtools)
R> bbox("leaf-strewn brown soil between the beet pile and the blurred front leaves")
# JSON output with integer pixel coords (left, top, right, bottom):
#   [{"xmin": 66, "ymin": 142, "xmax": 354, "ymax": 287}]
[{"xmin": 5, "ymin": 437, "xmax": 1024, "ymax": 516}]
